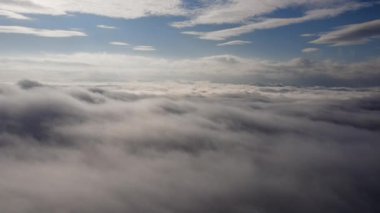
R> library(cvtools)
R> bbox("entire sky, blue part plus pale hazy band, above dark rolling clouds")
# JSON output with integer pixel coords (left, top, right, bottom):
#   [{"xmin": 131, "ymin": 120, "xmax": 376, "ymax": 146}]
[{"xmin": 0, "ymin": 0, "xmax": 380, "ymax": 86}]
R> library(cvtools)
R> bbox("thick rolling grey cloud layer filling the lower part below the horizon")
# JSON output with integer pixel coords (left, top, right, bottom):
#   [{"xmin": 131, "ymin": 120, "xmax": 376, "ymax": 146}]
[{"xmin": 0, "ymin": 83, "xmax": 380, "ymax": 213}]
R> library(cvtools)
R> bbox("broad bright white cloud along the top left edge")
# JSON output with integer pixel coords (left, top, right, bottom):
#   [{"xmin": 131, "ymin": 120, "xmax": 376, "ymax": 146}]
[{"xmin": 0, "ymin": 0, "xmax": 185, "ymax": 19}]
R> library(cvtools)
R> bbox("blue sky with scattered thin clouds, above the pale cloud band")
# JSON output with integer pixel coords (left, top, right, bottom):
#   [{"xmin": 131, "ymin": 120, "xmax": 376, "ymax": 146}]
[{"xmin": 0, "ymin": 0, "xmax": 380, "ymax": 85}]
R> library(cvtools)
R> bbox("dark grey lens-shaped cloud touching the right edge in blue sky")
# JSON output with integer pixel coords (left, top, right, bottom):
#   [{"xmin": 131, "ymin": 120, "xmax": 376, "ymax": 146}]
[{"xmin": 311, "ymin": 19, "xmax": 380, "ymax": 46}]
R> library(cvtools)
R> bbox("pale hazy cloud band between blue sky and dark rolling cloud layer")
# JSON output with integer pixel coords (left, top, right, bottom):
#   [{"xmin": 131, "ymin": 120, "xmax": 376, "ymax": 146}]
[{"xmin": 0, "ymin": 53, "xmax": 380, "ymax": 87}]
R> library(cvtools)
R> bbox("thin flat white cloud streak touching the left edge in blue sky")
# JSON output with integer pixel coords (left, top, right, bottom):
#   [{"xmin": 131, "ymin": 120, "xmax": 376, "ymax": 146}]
[{"xmin": 0, "ymin": 26, "xmax": 87, "ymax": 38}]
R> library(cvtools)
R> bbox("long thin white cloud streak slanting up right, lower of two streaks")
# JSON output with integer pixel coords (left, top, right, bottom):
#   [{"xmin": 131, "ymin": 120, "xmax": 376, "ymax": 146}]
[{"xmin": 183, "ymin": 3, "xmax": 369, "ymax": 40}]
